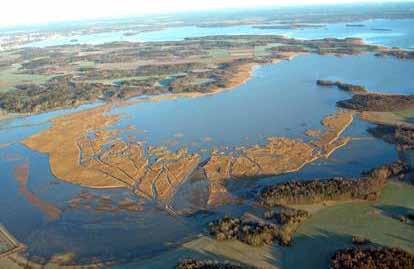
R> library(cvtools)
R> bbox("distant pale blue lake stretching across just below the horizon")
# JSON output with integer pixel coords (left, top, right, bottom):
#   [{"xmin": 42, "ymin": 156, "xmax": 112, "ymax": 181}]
[{"xmin": 26, "ymin": 19, "xmax": 414, "ymax": 49}]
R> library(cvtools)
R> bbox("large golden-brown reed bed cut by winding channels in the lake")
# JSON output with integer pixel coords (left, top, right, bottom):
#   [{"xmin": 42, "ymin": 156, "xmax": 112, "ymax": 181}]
[{"xmin": 23, "ymin": 103, "xmax": 353, "ymax": 207}]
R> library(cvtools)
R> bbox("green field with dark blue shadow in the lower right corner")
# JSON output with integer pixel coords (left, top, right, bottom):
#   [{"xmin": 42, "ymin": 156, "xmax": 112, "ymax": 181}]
[{"xmin": 281, "ymin": 182, "xmax": 414, "ymax": 268}]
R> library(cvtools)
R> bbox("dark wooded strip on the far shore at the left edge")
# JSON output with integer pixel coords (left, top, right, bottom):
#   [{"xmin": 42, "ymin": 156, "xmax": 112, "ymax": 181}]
[{"xmin": 0, "ymin": 76, "xmax": 166, "ymax": 113}]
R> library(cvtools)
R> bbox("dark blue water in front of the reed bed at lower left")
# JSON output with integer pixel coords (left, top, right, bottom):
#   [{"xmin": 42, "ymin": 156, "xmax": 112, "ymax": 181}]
[{"xmin": 0, "ymin": 144, "xmax": 206, "ymax": 263}]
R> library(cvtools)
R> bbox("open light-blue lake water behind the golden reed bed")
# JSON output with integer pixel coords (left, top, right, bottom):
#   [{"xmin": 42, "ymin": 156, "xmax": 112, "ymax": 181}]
[{"xmin": 109, "ymin": 55, "xmax": 414, "ymax": 152}]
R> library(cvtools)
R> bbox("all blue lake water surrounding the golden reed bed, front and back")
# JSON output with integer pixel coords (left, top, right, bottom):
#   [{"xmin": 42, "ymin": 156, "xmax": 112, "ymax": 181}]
[{"xmin": 0, "ymin": 54, "xmax": 414, "ymax": 262}]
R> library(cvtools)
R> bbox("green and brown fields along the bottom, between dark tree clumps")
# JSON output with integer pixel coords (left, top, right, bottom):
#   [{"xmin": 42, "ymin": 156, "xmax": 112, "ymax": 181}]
[{"xmin": 108, "ymin": 182, "xmax": 414, "ymax": 269}]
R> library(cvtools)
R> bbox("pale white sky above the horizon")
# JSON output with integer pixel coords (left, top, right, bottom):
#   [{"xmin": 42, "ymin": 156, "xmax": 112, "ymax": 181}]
[{"xmin": 0, "ymin": 0, "xmax": 410, "ymax": 26}]
